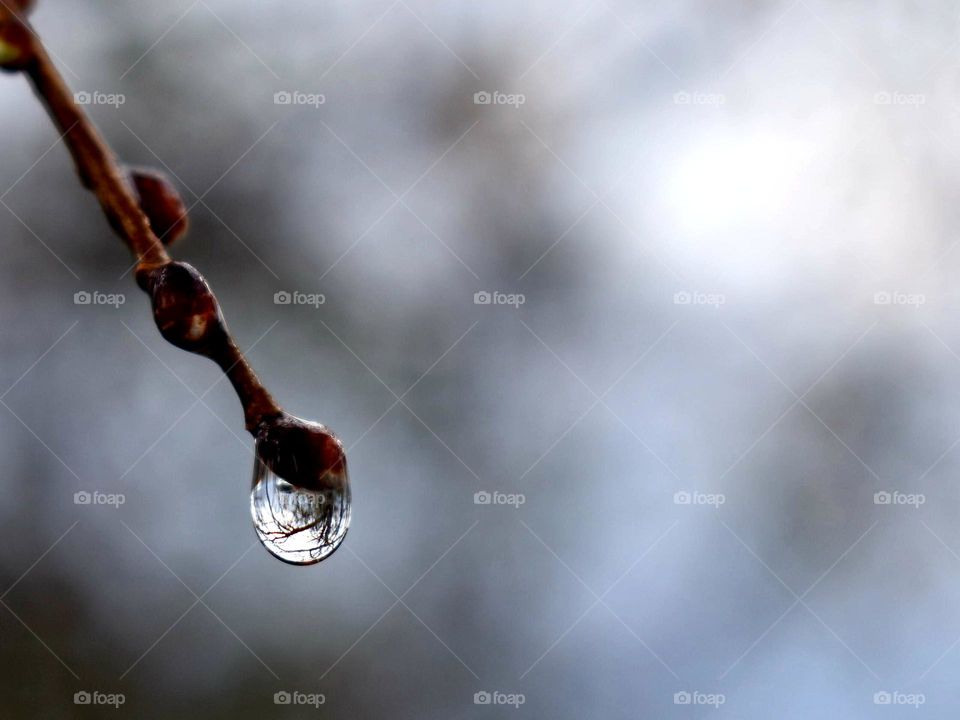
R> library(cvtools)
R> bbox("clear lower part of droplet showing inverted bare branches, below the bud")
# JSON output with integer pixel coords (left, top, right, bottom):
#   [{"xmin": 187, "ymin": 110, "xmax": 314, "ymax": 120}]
[{"xmin": 250, "ymin": 457, "xmax": 350, "ymax": 565}]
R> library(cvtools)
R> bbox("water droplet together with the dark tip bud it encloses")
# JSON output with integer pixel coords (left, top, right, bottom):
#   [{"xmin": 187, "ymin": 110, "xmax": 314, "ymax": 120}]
[{"xmin": 250, "ymin": 415, "xmax": 350, "ymax": 565}]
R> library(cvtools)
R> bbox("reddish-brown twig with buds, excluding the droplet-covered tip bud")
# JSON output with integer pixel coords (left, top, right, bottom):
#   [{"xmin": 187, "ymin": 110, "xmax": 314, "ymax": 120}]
[{"xmin": 0, "ymin": 7, "xmax": 284, "ymax": 437}]
